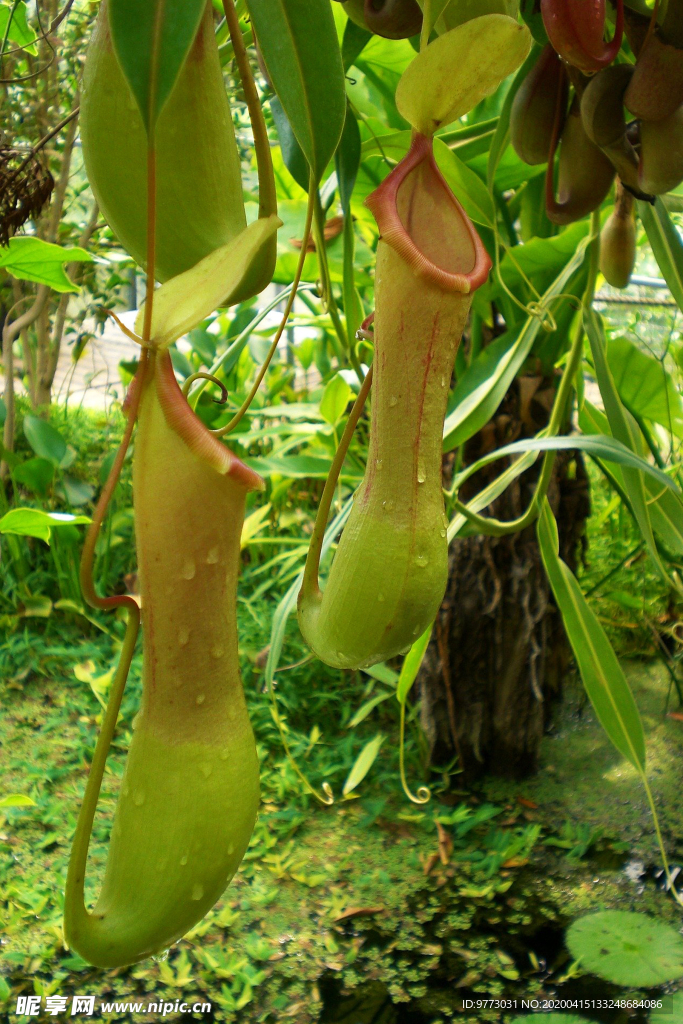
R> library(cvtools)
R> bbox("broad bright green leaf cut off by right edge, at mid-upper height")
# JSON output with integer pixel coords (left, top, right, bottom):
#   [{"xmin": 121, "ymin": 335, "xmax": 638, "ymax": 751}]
[{"xmin": 607, "ymin": 338, "xmax": 683, "ymax": 437}]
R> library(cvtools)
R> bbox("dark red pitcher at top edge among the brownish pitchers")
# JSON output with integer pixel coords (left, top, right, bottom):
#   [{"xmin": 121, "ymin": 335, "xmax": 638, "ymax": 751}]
[{"xmin": 541, "ymin": 0, "xmax": 624, "ymax": 72}]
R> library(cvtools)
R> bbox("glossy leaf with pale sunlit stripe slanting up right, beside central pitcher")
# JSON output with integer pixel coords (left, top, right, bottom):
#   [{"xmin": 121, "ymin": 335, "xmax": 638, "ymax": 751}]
[{"xmin": 443, "ymin": 244, "xmax": 586, "ymax": 452}]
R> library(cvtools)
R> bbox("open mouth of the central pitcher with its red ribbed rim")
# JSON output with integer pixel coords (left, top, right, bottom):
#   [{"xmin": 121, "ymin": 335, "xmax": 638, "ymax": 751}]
[{"xmin": 366, "ymin": 132, "xmax": 492, "ymax": 295}]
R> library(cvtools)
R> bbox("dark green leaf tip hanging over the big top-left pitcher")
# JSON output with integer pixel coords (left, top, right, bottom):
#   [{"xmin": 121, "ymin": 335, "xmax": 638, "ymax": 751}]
[{"xmin": 109, "ymin": 0, "xmax": 206, "ymax": 134}]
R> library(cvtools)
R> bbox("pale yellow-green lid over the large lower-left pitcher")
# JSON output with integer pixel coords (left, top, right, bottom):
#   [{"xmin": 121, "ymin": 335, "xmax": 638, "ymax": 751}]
[{"xmin": 135, "ymin": 215, "xmax": 282, "ymax": 348}]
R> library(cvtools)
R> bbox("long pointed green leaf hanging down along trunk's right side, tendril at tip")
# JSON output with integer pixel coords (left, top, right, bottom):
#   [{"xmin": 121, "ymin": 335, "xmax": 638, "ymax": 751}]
[{"xmin": 537, "ymin": 500, "xmax": 645, "ymax": 771}]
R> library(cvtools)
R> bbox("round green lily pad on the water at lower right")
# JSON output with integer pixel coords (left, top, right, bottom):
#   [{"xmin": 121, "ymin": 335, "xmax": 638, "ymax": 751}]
[{"xmin": 566, "ymin": 910, "xmax": 683, "ymax": 988}]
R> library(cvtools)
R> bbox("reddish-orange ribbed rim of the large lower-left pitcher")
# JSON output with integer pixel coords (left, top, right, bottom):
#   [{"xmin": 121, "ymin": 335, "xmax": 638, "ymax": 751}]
[{"xmin": 155, "ymin": 351, "xmax": 265, "ymax": 490}]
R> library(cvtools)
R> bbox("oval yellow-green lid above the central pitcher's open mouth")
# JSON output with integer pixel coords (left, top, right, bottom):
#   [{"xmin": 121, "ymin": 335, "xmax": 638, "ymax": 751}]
[{"xmin": 396, "ymin": 14, "xmax": 531, "ymax": 135}]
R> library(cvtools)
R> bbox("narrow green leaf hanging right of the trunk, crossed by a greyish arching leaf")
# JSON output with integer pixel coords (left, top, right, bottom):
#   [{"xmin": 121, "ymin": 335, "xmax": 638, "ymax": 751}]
[{"xmin": 584, "ymin": 309, "xmax": 671, "ymax": 583}]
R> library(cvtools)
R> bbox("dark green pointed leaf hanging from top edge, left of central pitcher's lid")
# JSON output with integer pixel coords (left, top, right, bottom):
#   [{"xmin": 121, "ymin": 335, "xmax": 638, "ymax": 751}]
[{"xmin": 245, "ymin": 0, "xmax": 346, "ymax": 181}]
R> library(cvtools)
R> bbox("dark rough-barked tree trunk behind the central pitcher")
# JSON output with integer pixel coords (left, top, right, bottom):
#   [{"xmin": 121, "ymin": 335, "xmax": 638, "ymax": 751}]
[{"xmin": 420, "ymin": 377, "xmax": 590, "ymax": 781}]
